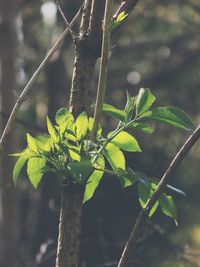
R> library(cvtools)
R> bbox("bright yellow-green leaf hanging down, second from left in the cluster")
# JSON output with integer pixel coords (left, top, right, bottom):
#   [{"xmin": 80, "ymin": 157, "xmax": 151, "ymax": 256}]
[{"xmin": 27, "ymin": 157, "xmax": 46, "ymax": 188}]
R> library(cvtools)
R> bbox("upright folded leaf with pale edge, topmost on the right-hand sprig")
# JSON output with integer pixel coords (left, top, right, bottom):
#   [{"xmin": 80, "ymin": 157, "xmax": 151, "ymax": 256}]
[{"xmin": 136, "ymin": 88, "xmax": 156, "ymax": 116}]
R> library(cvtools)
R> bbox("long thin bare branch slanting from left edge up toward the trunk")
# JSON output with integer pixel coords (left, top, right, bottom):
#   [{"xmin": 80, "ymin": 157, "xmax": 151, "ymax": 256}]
[{"xmin": 0, "ymin": 9, "xmax": 81, "ymax": 154}]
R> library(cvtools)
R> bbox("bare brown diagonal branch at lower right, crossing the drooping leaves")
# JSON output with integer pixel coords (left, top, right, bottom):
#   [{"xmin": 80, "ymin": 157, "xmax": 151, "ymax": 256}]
[{"xmin": 118, "ymin": 125, "xmax": 200, "ymax": 267}]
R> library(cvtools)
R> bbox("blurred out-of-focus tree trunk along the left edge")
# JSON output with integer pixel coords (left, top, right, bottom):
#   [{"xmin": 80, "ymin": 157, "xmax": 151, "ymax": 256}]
[{"xmin": 0, "ymin": 0, "xmax": 17, "ymax": 267}]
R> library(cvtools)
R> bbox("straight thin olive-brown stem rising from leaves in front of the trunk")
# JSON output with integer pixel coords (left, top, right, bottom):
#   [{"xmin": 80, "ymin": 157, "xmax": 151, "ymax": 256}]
[{"xmin": 91, "ymin": 0, "xmax": 113, "ymax": 140}]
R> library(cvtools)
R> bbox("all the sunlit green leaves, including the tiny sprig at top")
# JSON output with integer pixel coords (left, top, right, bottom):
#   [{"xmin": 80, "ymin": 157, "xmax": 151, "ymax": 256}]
[{"xmin": 13, "ymin": 88, "xmax": 194, "ymax": 223}]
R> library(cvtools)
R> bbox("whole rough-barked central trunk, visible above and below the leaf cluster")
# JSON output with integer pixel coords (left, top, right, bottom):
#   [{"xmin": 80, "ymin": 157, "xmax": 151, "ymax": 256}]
[{"xmin": 56, "ymin": 0, "xmax": 105, "ymax": 267}]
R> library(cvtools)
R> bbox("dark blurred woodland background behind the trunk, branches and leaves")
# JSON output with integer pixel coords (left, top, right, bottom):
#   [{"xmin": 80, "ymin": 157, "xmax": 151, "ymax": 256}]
[{"xmin": 0, "ymin": 0, "xmax": 200, "ymax": 267}]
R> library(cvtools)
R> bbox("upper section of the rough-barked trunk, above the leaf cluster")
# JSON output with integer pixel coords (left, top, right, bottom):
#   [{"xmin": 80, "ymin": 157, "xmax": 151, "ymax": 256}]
[{"xmin": 69, "ymin": 0, "xmax": 105, "ymax": 116}]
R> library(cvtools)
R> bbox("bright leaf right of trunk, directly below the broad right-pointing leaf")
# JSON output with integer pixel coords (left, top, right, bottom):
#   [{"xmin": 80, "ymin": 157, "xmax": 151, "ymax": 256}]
[{"xmin": 105, "ymin": 143, "xmax": 126, "ymax": 171}]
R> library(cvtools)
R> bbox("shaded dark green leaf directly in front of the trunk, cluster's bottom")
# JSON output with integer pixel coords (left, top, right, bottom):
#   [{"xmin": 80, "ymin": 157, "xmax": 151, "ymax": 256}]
[{"xmin": 67, "ymin": 159, "xmax": 92, "ymax": 184}]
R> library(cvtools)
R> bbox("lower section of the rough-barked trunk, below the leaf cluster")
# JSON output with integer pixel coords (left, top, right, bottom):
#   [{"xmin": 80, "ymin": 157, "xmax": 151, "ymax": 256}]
[{"xmin": 56, "ymin": 184, "xmax": 84, "ymax": 267}]
